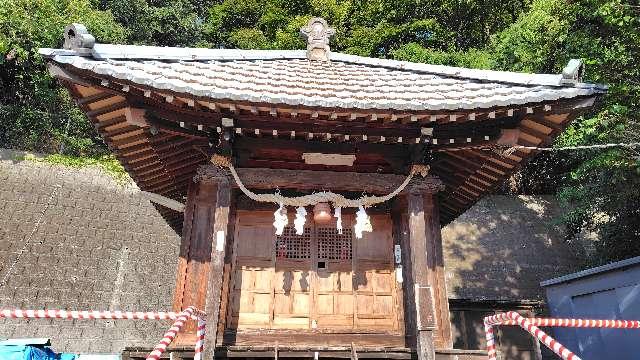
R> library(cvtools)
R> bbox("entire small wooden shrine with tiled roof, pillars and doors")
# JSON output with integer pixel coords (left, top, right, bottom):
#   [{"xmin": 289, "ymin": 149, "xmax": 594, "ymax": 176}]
[{"xmin": 40, "ymin": 19, "xmax": 605, "ymax": 359}]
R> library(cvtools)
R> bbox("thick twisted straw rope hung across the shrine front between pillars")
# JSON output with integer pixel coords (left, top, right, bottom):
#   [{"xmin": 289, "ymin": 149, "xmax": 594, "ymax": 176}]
[{"xmin": 211, "ymin": 155, "xmax": 429, "ymax": 208}]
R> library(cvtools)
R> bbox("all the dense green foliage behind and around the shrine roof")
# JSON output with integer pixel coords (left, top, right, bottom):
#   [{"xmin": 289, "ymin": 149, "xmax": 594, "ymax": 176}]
[{"xmin": 0, "ymin": 0, "xmax": 640, "ymax": 261}]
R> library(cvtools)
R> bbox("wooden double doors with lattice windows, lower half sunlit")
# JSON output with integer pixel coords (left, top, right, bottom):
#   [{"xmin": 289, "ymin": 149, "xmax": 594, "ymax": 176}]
[{"xmin": 227, "ymin": 211, "xmax": 402, "ymax": 333}]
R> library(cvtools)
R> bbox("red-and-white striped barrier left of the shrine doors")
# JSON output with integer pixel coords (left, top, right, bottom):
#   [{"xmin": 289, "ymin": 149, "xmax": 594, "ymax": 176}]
[{"xmin": 0, "ymin": 306, "xmax": 206, "ymax": 360}]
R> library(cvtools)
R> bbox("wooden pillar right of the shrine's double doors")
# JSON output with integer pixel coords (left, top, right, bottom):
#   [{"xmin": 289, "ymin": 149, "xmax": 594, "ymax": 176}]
[{"xmin": 394, "ymin": 178, "xmax": 453, "ymax": 360}]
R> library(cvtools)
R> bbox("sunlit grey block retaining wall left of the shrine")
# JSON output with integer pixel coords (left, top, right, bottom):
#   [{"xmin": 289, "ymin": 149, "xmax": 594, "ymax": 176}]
[{"xmin": 0, "ymin": 151, "xmax": 180, "ymax": 353}]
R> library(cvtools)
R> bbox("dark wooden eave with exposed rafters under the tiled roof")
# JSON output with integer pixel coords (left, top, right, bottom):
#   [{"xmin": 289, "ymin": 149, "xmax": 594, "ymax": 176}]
[{"xmin": 55, "ymin": 63, "xmax": 597, "ymax": 231}]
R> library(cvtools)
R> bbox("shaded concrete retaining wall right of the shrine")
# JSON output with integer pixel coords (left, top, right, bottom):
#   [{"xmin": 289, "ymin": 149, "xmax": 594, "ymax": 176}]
[{"xmin": 442, "ymin": 195, "xmax": 584, "ymax": 301}]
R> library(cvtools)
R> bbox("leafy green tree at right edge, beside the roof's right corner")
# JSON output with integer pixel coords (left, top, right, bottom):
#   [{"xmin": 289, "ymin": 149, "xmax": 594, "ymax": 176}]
[{"xmin": 490, "ymin": 0, "xmax": 640, "ymax": 264}]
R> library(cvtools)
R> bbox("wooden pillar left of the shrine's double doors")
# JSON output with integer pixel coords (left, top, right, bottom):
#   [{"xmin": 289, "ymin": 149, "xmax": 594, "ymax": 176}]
[{"xmin": 173, "ymin": 166, "xmax": 232, "ymax": 352}]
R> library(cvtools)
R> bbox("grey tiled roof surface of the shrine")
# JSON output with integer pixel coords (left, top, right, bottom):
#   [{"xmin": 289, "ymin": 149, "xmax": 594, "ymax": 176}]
[{"xmin": 41, "ymin": 44, "xmax": 604, "ymax": 111}]
